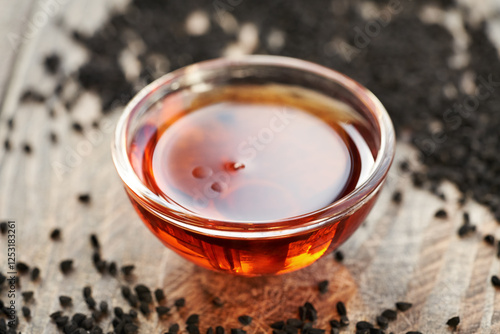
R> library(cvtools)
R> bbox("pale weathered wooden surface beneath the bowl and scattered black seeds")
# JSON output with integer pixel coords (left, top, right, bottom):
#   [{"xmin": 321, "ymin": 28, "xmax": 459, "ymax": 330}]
[{"xmin": 0, "ymin": 0, "xmax": 500, "ymax": 333}]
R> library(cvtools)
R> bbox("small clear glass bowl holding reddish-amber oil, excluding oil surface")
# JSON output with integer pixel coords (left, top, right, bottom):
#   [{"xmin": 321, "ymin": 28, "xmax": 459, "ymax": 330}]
[{"xmin": 112, "ymin": 56, "xmax": 395, "ymax": 276}]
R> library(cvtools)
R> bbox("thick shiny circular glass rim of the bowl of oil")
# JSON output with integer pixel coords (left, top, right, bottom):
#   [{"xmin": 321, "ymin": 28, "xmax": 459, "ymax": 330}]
[{"xmin": 111, "ymin": 55, "xmax": 395, "ymax": 238}]
